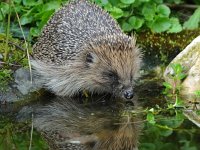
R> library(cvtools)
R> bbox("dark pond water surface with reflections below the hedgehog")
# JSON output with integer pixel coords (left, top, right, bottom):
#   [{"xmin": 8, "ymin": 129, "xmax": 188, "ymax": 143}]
[{"xmin": 0, "ymin": 80, "xmax": 200, "ymax": 150}]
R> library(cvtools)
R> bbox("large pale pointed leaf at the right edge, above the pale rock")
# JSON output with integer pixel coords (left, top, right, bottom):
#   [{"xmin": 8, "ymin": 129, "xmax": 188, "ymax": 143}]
[{"xmin": 183, "ymin": 7, "xmax": 200, "ymax": 30}]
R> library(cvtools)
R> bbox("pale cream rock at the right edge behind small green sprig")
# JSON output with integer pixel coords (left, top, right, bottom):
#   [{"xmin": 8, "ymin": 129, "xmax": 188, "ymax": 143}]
[{"xmin": 164, "ymin": 36, "xmax": 200, "ymax": 95}]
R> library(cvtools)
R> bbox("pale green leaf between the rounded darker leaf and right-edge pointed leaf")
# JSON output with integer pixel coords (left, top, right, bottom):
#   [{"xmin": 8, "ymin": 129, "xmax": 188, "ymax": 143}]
[{"xmin": 167, "ymin": 18, "xmax": 182, "ymax": 33}]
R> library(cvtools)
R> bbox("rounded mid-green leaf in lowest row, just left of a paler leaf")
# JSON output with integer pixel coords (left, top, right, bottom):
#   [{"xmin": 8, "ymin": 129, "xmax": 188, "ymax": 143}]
[{"xmin": 150, "ymin": 17, "xmax": 171, "ymax": 33}]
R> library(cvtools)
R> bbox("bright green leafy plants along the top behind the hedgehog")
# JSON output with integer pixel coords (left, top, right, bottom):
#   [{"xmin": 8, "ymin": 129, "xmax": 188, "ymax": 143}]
[{"xmin": 0, "ymin": 0, "xmax": 200, "ymax": 39}]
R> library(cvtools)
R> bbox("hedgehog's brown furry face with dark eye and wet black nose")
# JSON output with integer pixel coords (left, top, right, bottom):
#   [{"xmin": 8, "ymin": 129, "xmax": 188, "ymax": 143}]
[{"xmin": 82, "ymin": 37, "xmax": 141, "ymax": 99}]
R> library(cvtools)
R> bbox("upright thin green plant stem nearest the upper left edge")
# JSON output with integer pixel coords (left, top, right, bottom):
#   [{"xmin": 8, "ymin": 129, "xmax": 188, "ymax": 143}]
[{"xmin": 4, "ymin": 0, "xmax": 11, "ymax": 62}]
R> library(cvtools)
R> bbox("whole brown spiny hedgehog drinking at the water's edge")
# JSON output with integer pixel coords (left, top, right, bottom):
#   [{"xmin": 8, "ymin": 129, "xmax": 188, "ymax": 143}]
[{"xmin": 31, "ymin": 0, "xmax": 141, "ymax": 100}]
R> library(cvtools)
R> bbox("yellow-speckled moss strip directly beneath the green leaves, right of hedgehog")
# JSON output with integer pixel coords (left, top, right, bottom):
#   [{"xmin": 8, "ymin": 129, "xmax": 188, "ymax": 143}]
[{"xmin": 137, "ymin": 28, "xmax": 200, "ymax": 52}]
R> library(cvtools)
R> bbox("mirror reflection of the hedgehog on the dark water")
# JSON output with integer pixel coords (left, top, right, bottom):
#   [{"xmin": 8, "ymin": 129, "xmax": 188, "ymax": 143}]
[{"xmin": 34, "ymin": 99, "xmax": 141, "ymax": 150}]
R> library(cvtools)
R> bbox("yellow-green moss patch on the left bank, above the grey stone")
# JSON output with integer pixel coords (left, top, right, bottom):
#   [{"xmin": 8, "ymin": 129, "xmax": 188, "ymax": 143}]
[{"xmin": 0, "ymin": 34, "xmax": 31, "ymax": 91}]
